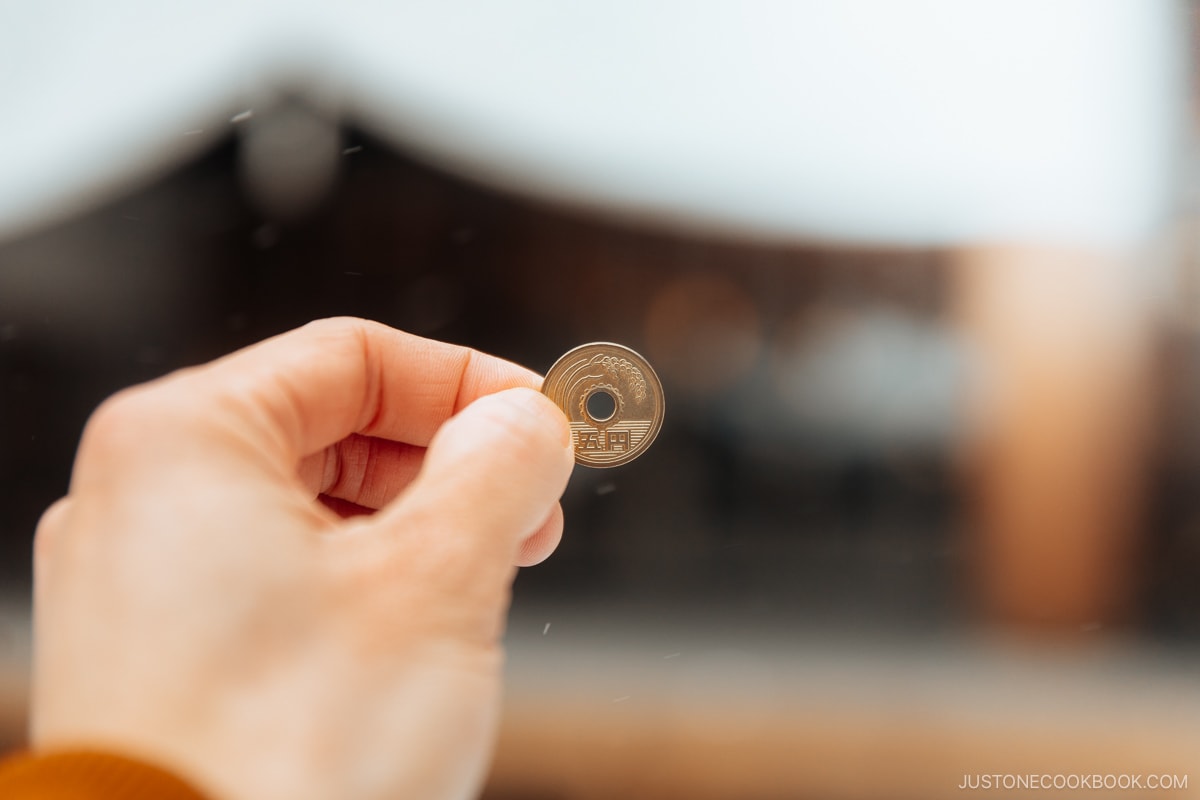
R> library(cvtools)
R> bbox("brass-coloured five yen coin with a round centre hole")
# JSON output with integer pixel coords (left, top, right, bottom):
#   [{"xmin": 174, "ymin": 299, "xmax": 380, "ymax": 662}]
[{"xmin": 541, "ymin": 342, "xmax": 664, "ymax": 467}]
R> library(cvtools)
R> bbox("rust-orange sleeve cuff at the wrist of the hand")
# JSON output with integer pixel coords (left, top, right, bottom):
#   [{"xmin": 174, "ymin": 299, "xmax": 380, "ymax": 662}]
[{"xmin": 0, "ymin": 750, "xmax": 210, "ymax": 800}]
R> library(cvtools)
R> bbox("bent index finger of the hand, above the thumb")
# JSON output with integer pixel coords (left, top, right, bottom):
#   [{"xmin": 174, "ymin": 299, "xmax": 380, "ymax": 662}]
[{"xmin": 168, "ymin": 318, "xmax": 541, "ymax": 462}]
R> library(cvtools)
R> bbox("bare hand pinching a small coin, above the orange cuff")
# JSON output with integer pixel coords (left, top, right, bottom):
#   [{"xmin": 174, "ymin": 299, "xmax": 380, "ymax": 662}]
[{"xmin": 31, "ymin": 319, "xmax": 572, "ymax": 800}]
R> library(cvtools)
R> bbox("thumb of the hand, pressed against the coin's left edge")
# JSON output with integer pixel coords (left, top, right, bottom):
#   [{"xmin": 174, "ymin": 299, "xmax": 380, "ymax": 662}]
[{"xmin": 376, "ymin": 389, "xmax": 575, "ymax": 575}]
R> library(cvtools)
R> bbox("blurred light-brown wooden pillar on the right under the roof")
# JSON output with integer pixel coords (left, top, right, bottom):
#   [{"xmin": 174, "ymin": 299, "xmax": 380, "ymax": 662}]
[{"xmin": 958, "ymin": 246, "xmax": 1150, "ymax": 631}]
